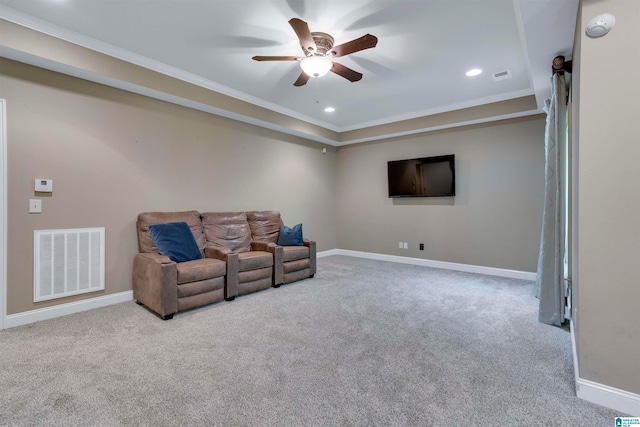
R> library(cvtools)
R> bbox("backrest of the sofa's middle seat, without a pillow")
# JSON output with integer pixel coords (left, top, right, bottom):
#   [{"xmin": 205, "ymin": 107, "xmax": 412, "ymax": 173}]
[{"xmin": 202, "ymin": 212, "xmax": 251, "ymax": 253}]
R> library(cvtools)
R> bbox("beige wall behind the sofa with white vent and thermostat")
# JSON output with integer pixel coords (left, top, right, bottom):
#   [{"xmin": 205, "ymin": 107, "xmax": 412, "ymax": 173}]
[{"xmin": 0, "ymin": 59, "xmax": 337, "ymax": 314}]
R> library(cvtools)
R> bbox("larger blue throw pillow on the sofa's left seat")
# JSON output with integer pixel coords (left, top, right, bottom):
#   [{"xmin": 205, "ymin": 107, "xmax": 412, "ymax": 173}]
[{"xmin": 149, "ymin": 222, "xmax": 202, "ymax": 262}]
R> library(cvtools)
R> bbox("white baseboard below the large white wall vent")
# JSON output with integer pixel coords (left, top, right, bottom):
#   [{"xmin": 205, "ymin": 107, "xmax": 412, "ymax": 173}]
[{"xmin": 4, "ymin": 291, "xmax": 133, "ymax": 329}]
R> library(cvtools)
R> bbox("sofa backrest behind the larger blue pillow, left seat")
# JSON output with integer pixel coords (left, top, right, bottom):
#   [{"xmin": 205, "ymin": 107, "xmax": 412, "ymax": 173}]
[{"xmin": 136, "ymin": 211, "xmax": 206, "ymax": 253}]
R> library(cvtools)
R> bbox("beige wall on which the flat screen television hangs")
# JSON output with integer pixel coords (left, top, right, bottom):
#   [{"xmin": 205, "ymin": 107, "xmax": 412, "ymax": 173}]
[{"xmin": 337, "ymin": 116, "xmax": 545, "ymax": 272}]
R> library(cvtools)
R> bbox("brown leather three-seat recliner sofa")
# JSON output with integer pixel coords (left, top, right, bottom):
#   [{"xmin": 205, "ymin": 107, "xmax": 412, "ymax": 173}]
[{"xmin": 132, "ymin": 211, "xmax": 316, "ymax": 320}]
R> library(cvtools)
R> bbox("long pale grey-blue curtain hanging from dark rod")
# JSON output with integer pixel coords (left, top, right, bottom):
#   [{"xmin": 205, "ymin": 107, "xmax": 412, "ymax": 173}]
[{"xmin": 536, "ymin": 73, "xmax": 567, "ymax": 326}]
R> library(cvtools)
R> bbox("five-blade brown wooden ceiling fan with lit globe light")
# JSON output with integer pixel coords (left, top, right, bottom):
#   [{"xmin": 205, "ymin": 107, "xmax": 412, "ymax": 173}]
[{"xmin": 253, "ymin": 18, "xmax": 378, "ymax": 86}]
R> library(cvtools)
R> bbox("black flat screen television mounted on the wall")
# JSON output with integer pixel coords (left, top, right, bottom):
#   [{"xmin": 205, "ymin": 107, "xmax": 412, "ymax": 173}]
[{"xmin": 387, "ymin": 154, "xmax": 456, "ymax": 197}]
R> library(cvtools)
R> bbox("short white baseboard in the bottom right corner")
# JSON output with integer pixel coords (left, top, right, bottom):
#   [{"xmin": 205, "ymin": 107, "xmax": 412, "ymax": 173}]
[{"xmin": 576, "ymin": 378, "xmax": 640, "ymax": 417}]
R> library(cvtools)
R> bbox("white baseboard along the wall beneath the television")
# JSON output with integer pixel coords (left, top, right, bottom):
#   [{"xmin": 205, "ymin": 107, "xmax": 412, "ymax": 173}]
[{"xmin": 332, "ymin": 249, "xmax": 536, "ymax": 280}]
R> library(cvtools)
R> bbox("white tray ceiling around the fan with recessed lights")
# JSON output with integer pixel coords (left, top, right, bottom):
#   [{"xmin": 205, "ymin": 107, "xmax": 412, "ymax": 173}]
[{"xmin": 0, "ymin": 0, "xmax": 578, "ymax": 136}]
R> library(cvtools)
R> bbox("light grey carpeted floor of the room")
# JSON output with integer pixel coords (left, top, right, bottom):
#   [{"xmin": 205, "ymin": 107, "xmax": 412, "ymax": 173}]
[{"xmin": 0, "ymin": 256, "xmax": 622, "ymax": 426}]
